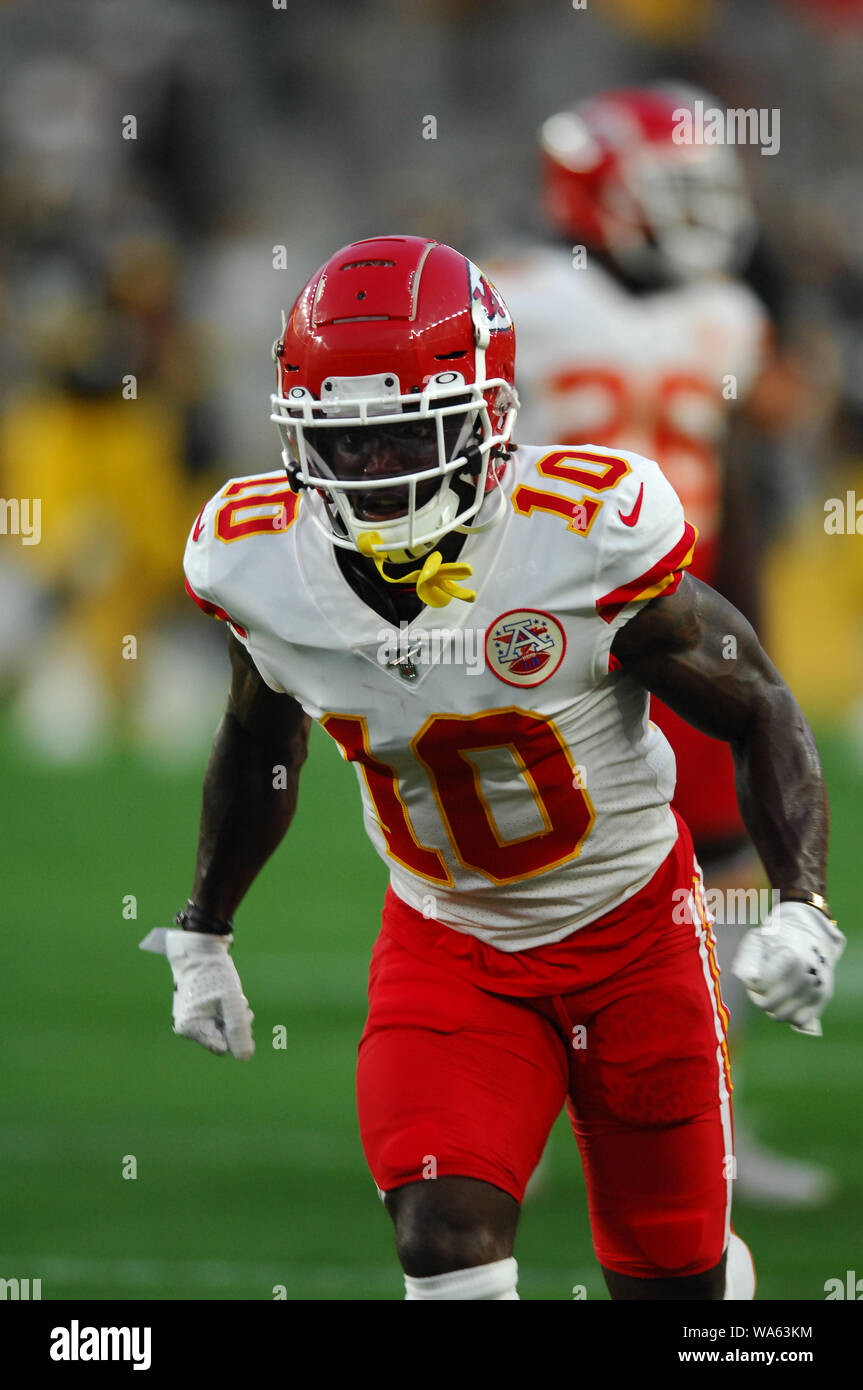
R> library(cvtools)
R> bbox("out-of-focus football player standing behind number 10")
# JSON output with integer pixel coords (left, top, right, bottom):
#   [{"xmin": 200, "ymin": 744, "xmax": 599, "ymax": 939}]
[{"xmin": 483, "ymin": 85, "xmax": 831, "ymax": 1205}]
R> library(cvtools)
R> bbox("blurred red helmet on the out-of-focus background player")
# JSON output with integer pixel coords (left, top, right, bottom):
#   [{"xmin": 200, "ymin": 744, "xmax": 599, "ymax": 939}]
[{"xmin": 541, "ymin": 85, "xmax": 756, "ymax": 284}]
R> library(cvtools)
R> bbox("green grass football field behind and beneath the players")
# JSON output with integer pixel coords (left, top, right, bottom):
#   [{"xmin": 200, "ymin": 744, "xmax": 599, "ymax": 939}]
[{"xmin": 0, "ymin": 731, "xmax": 863, "ymax": 1300}]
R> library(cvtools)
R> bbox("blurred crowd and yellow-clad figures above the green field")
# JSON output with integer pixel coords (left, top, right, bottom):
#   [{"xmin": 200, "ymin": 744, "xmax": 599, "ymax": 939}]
[{"xmin": 0, "ymin": 0, "xmax": 863, "ymax": 759}]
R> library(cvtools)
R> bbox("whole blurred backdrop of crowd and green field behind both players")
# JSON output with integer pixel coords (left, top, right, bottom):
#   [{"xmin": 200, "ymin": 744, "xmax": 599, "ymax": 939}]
[{"xmin": 0, "ymin": 0, "xmax": 863, "ymax": 1300}]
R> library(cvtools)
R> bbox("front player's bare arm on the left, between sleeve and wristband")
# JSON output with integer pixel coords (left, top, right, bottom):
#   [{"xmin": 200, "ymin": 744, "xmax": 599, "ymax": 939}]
[{"xmin": 192, "ymin": 631, "xmax": 311, "ymax": 920}]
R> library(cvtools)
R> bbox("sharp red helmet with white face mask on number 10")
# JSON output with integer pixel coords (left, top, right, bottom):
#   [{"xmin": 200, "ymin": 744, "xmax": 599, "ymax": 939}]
[{"xmin": 270, "ymin": 236, "xmax": 518, "ymax": 555}]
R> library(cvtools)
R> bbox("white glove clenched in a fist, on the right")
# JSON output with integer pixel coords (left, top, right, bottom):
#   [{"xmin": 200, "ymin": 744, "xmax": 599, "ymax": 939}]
[{"xmin": 731, "ymin": 902, "xmax": 845, "ymax": 1038}]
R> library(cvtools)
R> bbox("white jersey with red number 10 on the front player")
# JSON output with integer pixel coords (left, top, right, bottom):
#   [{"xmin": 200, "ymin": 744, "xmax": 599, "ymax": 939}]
[{"xmin": 185, "ymin": 445, "xmax": 695, "ymax": 951}]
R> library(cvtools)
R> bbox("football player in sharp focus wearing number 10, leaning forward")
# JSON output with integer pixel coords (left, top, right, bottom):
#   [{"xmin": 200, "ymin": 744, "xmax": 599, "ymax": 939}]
[{"xmin": 143, "ymin": 236, "xmax": 845, "ymax": 1300}]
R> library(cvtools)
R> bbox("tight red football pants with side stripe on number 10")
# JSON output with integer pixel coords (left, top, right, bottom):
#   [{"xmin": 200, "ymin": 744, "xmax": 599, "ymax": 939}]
[{"xmin": 357, "ymin": 821, "xmax": 732, "ymax": 1277}]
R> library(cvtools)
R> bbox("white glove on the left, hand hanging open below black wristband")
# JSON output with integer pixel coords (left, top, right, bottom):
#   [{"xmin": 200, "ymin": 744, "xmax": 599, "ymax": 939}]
[{"xmin": 140, "ymin": 927, "xmax": 254, "ymax": 1062}]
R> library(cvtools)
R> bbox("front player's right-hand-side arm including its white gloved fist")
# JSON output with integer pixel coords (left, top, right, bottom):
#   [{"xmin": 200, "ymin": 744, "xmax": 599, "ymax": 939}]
[{"xmin": 613, "ymin": 577, "xmax": 845, "ymax": 1037}]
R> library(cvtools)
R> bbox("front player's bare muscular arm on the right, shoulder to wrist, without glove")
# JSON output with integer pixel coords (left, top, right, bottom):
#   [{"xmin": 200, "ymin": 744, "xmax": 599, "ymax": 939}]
[{"xmin": 611, "ymin": 575, "xmax": 828, "ymax": 895}]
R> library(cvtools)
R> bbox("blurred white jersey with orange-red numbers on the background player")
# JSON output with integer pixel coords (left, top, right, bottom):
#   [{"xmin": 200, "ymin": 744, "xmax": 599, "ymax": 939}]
[{"xmin": 491, "ymin": 247, "xmax": 769, "ymax": 582}]
